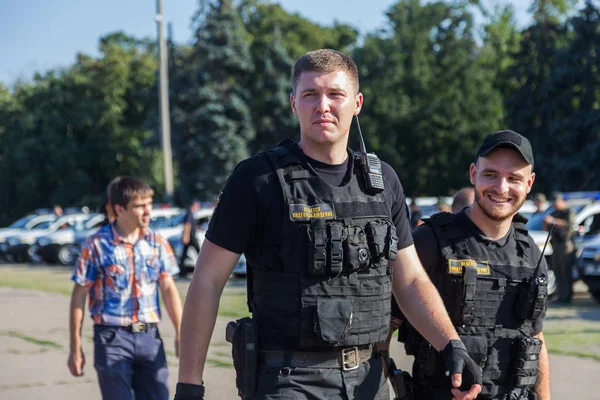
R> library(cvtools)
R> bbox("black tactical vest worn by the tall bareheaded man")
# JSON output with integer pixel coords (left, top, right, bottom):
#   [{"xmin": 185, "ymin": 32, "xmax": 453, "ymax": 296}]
[{"xmin": 250, "ymin": 141, "xmax": 398, "ymax": 350}]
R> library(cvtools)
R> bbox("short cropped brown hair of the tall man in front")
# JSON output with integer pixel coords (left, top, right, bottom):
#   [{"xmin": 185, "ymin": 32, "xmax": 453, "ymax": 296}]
[{"xmin": 292, "ymin": 49, "xmax": 359, "ymax": 93}]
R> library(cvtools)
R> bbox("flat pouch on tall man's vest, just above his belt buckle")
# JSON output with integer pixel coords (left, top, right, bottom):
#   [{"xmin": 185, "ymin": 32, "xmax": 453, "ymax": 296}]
[{"xmin": 317, "ymin": 297, "xmax": 354, "ymax": 344}]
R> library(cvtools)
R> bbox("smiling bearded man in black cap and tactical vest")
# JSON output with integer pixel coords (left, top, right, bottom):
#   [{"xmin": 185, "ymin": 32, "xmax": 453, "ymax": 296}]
[{"xmin": 392, "ymin": 131, "xmax": 550, "ymax": 400}]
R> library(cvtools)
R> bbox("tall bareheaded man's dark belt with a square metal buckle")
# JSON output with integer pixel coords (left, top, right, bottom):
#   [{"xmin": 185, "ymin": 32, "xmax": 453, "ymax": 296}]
[{"xmin": 258, "ymin": 344, "xmax": 374, "ymax": 371}]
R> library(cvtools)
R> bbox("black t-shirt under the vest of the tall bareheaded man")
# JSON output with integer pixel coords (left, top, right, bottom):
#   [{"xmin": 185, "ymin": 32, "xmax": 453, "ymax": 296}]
[{"xmin": 206, "ymin": 147, "xmax": 413, "ymax": 260}]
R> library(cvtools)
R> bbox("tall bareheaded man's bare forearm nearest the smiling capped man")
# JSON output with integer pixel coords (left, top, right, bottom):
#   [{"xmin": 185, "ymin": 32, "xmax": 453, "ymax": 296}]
[{"xmin": 394, "ymin": 278, "xmax": 459, "ymax": 351}]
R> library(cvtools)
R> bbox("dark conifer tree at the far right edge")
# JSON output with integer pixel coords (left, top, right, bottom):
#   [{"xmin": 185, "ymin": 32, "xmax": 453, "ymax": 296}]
[{"xmin": 541, "ymin": 1, "xmax": 600, "ymax": 190}]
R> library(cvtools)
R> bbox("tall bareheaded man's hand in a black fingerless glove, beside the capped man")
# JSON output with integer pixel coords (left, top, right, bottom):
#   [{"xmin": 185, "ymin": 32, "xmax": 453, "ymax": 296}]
[{"xmin": 442, "ymin": 339, "xmax": 482, "ymax": 400}]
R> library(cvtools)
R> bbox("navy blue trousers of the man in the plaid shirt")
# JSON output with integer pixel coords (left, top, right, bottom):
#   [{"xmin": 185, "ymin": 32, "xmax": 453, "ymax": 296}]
[{"xmin": 94, "ymin": 325, "xmax": 169, "ymax": 400}]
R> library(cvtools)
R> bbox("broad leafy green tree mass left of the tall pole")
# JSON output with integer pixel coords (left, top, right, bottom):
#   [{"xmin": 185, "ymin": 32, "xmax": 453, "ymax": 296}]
[{"xmin": 4, "ymin": 33, "xmax": 160, "ymax": 220}]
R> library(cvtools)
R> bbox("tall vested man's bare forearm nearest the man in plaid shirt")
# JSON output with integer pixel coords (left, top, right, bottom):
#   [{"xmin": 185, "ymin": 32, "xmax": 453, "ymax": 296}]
[{"xmin": 179, "ymin": 271, "xmax": 222, "ymax": 385}]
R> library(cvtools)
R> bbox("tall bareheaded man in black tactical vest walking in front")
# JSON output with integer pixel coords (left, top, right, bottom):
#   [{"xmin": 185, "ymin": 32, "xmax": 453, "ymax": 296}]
[{"xmin": 175, "ymin": 50, "xmax": 481, "ymax": 400}]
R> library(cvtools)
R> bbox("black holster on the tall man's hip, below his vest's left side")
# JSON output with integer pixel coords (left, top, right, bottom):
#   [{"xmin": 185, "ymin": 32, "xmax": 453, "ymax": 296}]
[{"xmin": 225, "ymin": 317, "xmax": 258, "ymax": 399}]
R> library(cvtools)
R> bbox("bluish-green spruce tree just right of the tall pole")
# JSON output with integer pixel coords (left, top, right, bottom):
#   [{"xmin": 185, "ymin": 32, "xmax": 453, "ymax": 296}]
[{"xmin": 172, "ymin": 0, "xmax": 255, "ymax": 202}]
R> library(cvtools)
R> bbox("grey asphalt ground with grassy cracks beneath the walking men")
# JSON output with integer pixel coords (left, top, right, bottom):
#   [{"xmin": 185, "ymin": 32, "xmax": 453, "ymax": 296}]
[{"xmin": 0, "ymin": 265, "xmax": 600, "ymax": 400}]
